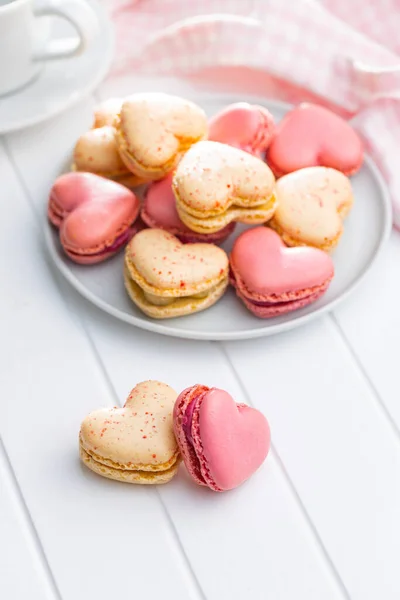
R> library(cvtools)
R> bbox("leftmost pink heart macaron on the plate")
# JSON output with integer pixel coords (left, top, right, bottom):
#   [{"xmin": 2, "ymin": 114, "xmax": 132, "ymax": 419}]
[{"xmin": 48, "ymin": 173, "xmax": 140, "ymax": 264}]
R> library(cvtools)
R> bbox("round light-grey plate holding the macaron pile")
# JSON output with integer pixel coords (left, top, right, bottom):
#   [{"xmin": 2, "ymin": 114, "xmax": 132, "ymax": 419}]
[{"xmin": 46, "ymin": 94, "xmax": 391, "ymax": 340}]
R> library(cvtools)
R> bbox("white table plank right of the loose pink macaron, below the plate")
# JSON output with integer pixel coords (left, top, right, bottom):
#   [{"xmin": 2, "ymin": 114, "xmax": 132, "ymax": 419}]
[{"xmin": 224, "ymin": 318, "xmax": 400, "ymax": 600}]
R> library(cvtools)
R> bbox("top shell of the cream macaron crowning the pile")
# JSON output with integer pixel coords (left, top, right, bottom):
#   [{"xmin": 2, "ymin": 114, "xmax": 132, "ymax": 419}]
[{"xmin": 173, "ymin": 141, "xmax": 275, "ymax": 218}]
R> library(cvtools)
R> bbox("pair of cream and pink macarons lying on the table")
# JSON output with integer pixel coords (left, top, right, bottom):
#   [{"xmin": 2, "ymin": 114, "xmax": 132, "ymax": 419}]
[{"xmin": 79, "ymin": 381, "xmax": 271, "ymax": 492}]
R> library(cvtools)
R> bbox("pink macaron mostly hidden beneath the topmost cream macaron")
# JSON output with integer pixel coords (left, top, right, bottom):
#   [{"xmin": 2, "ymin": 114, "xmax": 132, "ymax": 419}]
[{"xmin": 141, "ymin": 174, "xmax": 236, "ymax": 244}]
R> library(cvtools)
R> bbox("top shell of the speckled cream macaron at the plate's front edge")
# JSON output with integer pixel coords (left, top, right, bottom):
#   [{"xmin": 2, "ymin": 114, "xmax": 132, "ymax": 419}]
[{"xmin": 125, "ymin": 229, "xmax": 229, "ymax": 297}]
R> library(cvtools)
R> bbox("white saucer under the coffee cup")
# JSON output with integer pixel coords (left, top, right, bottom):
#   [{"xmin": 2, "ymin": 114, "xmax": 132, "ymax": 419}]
[{"xmin": 0, "ymin": 0, "xmax": 114, "ymax": 135}]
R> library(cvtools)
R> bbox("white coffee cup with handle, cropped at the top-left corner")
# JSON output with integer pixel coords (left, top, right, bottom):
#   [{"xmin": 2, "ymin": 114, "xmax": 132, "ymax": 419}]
[{"xmin": 0, "ymin": 0, "xmax": 99, "ymax": 96}]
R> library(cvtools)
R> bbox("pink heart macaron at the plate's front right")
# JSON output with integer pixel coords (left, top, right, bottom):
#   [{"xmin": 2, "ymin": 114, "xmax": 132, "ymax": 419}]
[{"xmin": 230, "ymin": 227, "xmax": 334, "ymax": 319}]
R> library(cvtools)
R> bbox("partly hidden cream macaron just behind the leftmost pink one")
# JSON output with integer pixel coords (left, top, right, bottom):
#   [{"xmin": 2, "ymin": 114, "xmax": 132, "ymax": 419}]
[{"xmin": 72, "ymin": 125, "xmax": 142, "ymax": 187}]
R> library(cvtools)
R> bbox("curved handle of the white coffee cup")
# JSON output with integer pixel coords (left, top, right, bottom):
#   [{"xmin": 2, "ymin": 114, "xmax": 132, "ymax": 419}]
[{"xmin": 34, "ymin": 0, "xmax": 100, "ymax": 61}]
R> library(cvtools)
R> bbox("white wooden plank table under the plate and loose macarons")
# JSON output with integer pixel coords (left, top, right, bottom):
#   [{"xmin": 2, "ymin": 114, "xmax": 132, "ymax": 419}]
[{"xmin": 0, "ymin": 74, "xmax": 400, "ymax": 600}]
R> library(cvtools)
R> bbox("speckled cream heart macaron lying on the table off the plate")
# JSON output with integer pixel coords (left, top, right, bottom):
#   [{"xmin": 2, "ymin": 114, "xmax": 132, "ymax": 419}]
[{"xmin": 79, "ymin": 381, "xmax": 180, "ymax": 484}]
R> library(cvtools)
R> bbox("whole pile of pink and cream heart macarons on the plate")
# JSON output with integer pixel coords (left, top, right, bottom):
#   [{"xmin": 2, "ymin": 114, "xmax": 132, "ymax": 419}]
[{"xmin": 48, "ymin": 93, "xmax": 363, "ymax": 319}]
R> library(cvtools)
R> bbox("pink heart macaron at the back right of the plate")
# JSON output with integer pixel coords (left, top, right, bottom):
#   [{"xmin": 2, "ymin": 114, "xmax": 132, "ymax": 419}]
[{"xmin": 267, "ymin": 103, "xmax": 363, "ymax": 176}]
